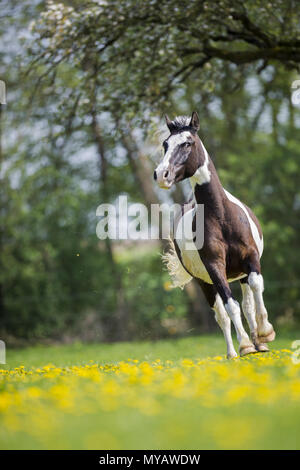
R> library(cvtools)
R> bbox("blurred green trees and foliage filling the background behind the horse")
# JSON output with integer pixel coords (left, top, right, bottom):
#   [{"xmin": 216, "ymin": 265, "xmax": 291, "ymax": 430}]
[{"xmin": 0, "ymin": 0, "xmax": 300, "ymax": 345}]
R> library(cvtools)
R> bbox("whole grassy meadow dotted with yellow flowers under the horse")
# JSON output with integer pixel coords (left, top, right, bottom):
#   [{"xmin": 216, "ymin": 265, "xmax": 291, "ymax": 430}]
[{"xmin": 0, "ymin": 334, "xmax": 300, "ymax": 449}]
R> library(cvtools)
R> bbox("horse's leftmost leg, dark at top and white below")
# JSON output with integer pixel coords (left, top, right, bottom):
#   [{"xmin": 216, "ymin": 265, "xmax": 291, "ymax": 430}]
[{"xmin": 197, "ymin": 279, "xmax": 237, "ymax": 359}]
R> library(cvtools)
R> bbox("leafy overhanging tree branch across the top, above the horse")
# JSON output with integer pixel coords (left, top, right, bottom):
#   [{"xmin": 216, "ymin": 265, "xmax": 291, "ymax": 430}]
[{"xmin": 32, "ymin": 0, "xmax": 300, "ymax": 112}]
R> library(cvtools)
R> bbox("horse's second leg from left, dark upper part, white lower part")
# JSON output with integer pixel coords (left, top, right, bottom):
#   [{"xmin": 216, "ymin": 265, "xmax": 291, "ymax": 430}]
[{"xmin": 203, "ymin": 259, "xmax": 257, "ymax": 356}]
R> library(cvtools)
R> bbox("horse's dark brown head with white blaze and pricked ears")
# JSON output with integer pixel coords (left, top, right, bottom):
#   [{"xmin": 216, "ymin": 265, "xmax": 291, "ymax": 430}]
[{"xmin": 154, "ymin": 111, "xmax": 205, "ymax": 189}]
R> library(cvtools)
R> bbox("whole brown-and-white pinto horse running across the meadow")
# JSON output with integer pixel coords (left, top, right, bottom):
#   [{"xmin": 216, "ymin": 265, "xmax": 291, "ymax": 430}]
[{"xmin": 154, "ymin": 111, "xmax": 275, "ymax": 359}]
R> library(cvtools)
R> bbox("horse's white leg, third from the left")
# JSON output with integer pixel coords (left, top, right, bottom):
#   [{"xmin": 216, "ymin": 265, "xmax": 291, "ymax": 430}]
[{"xmin": 240, "ymin": 278, "xmax": 269, "ymax": 352}]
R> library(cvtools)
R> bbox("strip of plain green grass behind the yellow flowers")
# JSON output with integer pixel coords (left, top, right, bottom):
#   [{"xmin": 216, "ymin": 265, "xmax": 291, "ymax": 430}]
[{"xmin": 2, "ymin": 332, "xmax": 292, "ymax": 369}]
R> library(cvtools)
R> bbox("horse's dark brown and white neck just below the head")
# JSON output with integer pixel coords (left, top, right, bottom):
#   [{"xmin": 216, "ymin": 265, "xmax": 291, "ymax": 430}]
[{"xmin": 190, "ymin": 157, "xmax": 224, "ymax": 218}]
